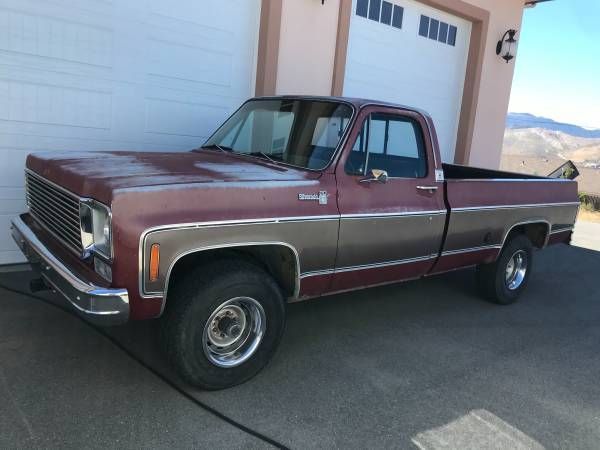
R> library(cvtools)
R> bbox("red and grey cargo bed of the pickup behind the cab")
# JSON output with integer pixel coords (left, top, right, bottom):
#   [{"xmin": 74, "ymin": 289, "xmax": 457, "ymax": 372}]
[{"xmin": 435, "ymin": 164, "xmax": 579, "ymax": 272}]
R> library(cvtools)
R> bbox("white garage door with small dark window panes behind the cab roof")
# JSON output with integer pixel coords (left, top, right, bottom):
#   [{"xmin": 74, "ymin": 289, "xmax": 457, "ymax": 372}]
[{"xmin": 344, "ymin": 0, "xmax": 471, "ymax": 162}]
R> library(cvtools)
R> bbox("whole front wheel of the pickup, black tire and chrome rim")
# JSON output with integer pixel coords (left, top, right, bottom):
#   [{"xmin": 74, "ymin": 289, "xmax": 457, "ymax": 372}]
[{"xmin": 161, "ymin": 260, "xmax": 285, "ymax": 390}]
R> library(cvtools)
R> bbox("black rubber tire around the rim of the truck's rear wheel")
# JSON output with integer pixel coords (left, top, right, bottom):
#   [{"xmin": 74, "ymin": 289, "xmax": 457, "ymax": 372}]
[{"xmin": 477, "ymin": 234, "xmax": 533, "ymax": 305}]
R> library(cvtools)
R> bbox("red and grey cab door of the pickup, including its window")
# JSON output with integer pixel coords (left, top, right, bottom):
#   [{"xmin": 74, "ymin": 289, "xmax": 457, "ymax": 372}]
[{"xmin": 332, "ymin": 106, "xmax": 446, "ymax": 291}]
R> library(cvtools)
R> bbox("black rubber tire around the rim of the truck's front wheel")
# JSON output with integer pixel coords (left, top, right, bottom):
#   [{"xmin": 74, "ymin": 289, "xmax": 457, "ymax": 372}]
[{"xmin": 160, "ymin": 259, "xmax": 285, "ymax": 390}]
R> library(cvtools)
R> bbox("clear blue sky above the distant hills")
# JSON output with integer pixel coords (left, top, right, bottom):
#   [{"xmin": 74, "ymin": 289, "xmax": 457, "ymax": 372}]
[{"xmin": 509, "ymin": 0, "xmax": 600, "ymax": 128}]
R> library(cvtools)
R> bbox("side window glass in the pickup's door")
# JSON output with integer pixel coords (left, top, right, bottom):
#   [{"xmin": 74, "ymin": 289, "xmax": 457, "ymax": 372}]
[{"xmin": 346, "ymin": 114, "xmax": 427, "ymax": 178}]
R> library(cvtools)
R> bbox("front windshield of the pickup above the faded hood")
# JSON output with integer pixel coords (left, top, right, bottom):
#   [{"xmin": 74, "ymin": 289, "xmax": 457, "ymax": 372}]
[{"xmin": 202, "ymin": 99, "xmax": 352, "ymax": 170}]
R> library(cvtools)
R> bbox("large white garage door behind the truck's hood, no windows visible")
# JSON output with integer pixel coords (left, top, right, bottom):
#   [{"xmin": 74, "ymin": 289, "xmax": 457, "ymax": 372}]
[{"xmin": 0, "ymin": 0, "xmax": 260, "ymax": 264}]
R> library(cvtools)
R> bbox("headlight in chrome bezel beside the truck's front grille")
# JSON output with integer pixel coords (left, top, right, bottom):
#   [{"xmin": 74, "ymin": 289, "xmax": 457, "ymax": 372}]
[{"xmin": 79, "ymin": 199, "xmax": 112, "ymax": 260}]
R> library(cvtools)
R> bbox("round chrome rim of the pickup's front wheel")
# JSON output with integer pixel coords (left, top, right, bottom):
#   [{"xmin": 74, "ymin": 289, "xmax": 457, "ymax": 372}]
[{"xmin": 202, "ymin": 297, "xmax": 267, "ymax": 367}]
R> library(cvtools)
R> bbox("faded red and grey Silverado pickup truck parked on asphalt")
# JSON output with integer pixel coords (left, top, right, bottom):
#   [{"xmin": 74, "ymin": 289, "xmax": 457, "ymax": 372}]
[{"xmin": 13, "ymin": 97, "xmax": 579, "ymax": 389}]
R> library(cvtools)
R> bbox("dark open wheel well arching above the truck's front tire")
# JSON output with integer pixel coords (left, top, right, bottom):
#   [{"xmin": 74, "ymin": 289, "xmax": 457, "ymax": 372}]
[{"xmin": 167, "ymin": 244, "xmax": 300, "ymax": 297}]
